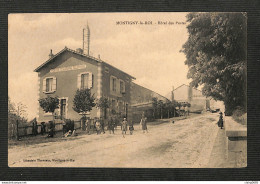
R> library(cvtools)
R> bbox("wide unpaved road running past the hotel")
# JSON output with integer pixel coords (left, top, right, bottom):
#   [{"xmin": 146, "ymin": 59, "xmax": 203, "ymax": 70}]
[{"xmin": 8, "ymin": 113, "xmax": 219, "ymax": 168}]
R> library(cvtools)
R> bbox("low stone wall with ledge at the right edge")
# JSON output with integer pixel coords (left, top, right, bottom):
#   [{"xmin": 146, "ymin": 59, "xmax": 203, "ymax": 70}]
[{"xmin": 224, "ymin": 116, "xmax": 247, "ymax": 167}]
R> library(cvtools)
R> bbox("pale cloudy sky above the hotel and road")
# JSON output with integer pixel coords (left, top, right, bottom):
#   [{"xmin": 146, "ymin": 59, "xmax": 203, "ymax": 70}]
[{"xmin": 8, "ymin": 12, "xmax": 190, "ymax": 119}]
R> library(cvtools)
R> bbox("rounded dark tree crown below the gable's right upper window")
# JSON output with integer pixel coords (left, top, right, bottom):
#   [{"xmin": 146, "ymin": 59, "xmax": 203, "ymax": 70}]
[{"xmin": 73, "ymin": 89, "xmax": 96, "ymax": 114}]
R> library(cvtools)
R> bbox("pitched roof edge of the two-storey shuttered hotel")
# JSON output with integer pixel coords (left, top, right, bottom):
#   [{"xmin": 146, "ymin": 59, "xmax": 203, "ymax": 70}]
[{"xmin": 34, "ymin": 47, "xmax": 136, "ymax": 79}]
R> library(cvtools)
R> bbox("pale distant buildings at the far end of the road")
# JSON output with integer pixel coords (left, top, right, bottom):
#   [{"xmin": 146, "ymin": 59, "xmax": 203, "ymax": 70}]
[{"xmin": 172, "ymin": 84, "xmax": 210, "ymax": 112}]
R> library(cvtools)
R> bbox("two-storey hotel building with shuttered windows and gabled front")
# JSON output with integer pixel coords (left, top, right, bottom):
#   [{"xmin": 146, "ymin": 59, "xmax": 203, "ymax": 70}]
[{"xmin": 34, "ymin": 47, "xmax": 135, "ymax": 121}]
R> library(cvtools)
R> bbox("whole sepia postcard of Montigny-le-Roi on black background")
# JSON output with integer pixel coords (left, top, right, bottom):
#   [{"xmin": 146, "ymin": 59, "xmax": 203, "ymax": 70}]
[{"xmin": 8, "ymin": 12, "xmax": 247, "ymax": 168}]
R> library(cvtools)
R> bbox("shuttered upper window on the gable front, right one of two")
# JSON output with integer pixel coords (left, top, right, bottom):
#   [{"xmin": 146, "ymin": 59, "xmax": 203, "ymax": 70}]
[{"xmin": 77, "ymin": 72, "xmax": 93, "ymax": 89}]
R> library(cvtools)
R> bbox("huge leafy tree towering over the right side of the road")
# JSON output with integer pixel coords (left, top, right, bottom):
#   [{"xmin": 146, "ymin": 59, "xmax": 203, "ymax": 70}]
[{"xmin": 181, "ymin": 13, "xmax": 247, "ymax": 115}]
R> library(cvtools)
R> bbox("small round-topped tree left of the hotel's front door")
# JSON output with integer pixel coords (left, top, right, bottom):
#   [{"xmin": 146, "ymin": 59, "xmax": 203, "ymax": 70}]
[{"xmin": 39, "ymin": 96, "xmax": 59, "ymax": 121}]
